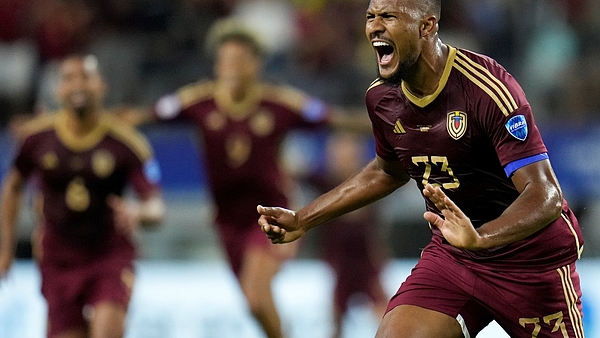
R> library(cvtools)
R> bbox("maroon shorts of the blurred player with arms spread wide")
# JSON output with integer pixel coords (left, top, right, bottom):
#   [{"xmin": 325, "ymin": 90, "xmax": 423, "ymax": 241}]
[{"xmin": 217, "ymin": 221, "xmax": 298, "ymax": 277}]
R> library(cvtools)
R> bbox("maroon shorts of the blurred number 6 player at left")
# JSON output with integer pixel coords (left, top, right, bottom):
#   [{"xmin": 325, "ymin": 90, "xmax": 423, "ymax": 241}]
[{"xmin": 40, "ymin": 259, "xmax": 134, "ymax": 336}]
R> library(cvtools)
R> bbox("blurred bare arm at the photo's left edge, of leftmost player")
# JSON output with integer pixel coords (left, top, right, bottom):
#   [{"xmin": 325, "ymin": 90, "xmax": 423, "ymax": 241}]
[{"xmin": 0, "ymin": 169, "xmax": 24, "ymax": 278}]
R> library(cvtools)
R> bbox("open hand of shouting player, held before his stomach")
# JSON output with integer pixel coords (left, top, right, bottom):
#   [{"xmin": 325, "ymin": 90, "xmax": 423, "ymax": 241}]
[{"xmin": 423, "ymin": 184, "xmax": 481, "ymax": 250}]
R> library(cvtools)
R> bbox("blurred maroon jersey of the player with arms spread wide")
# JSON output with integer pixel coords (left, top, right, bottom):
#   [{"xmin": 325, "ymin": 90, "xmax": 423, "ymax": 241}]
[{"xmin": 154, "ymin": 81, "xmax": 329, "ymax": 224}]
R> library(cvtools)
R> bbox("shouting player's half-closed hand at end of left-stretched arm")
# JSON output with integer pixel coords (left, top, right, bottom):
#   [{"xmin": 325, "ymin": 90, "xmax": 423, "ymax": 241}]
[{"xmin": 256, "ymin": 205, "xmax": 306, "ymax": 244}]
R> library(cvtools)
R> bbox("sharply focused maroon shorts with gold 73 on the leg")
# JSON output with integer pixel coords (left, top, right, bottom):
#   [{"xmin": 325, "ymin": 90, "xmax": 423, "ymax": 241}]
[{"xmin": 387, "ymin": 245, "xmax": 583, "ymax": 338}]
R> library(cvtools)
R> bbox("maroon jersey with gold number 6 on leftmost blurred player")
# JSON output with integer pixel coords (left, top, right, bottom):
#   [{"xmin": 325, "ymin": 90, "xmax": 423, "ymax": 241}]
[{"xmin": 14, "ymin": 112, "xmax": 158, "ymax": 265}]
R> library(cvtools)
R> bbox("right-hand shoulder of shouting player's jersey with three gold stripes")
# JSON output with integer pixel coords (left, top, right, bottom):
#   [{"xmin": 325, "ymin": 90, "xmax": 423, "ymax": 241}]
[{"xmin": 453, "ymin": 48, "xmax": 527, "ymax": 115}]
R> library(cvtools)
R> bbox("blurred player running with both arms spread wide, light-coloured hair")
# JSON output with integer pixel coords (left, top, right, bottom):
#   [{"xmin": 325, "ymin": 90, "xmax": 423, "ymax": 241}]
[{"xmin": 126, "ymin": 21, "xmax": 368, "ymax": 338}]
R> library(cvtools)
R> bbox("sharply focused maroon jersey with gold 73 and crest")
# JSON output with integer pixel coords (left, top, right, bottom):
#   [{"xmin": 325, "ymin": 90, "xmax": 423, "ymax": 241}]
[{"xmin": 366, "ymin": 47, "xmax": 583, "ymax": 266}]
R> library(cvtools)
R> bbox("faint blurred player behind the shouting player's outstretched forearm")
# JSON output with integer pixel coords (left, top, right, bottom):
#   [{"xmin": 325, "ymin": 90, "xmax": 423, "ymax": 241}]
[{"xmin": 308, "ymin": 131, "xmax": 389, "ymax": 338}]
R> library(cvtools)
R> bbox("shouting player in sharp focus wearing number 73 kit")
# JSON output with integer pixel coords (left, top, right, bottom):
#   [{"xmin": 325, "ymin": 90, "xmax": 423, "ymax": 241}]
[{"xmin": 258, "ymin": 0, "xmax": 584, "ymax": 338}]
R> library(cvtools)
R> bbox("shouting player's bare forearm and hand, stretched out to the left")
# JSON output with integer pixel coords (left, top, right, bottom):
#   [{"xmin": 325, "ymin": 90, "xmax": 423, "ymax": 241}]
[{"xmin": 257, "ymin": 157, "xmax": 409, "ymax": 243}]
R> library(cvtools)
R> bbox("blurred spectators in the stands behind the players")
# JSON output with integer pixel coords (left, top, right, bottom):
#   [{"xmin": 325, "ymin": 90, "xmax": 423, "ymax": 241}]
[{"xmin": 0, "ymin": 0, "xmax": 600, "ymax": 125}]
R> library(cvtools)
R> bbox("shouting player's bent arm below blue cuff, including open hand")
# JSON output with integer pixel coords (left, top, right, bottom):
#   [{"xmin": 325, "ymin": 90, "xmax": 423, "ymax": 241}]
[{"xmin": 423, "ymin": 160, "xmax": 563, "ymax": 250}]
